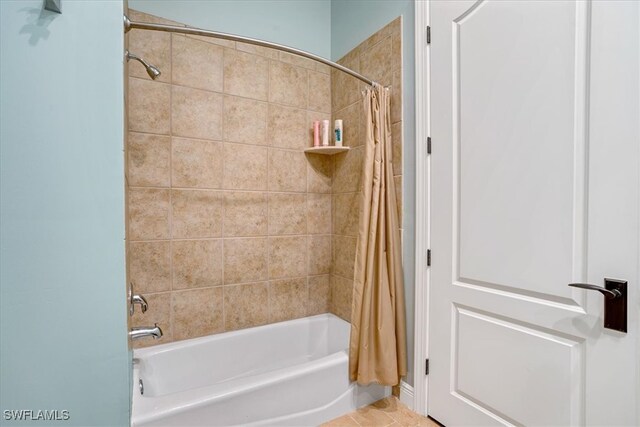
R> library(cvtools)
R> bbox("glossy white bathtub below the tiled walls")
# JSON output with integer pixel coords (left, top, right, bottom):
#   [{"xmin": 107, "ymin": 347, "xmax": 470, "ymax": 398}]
[{"xmin": 131, "ymin": 314, "xmax": 390, "ymax": 427}]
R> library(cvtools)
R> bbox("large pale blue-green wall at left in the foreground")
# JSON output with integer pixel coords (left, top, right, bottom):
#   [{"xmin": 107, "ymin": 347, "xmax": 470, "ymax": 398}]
[{"xmin": 0, "ymin": 0, "xmax": 129, "ymax": 426}]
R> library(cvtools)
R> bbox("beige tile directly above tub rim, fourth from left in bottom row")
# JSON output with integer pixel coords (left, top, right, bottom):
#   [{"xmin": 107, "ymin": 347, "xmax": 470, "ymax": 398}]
[{"xmin": 269, "ymin": 278, "xmax": 307, "ymax": 322}]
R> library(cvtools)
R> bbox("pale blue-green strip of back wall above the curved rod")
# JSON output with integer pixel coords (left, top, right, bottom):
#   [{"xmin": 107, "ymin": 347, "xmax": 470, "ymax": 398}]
[{"xmin": 129, "ymin": 0, "xmax": 331, "ymax": 58}]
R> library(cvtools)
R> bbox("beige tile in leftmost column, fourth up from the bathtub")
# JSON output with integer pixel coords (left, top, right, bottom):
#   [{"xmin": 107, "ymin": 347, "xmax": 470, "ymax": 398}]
[{"xmin": 127, "ymin": 132, "xmax": 171, "ymax": 187}]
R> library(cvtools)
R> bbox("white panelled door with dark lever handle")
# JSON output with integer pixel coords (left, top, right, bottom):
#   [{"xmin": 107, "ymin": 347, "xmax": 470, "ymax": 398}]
[{"xmin": 428, "ymin": 0, "xmax": 640, "ymax": 427}]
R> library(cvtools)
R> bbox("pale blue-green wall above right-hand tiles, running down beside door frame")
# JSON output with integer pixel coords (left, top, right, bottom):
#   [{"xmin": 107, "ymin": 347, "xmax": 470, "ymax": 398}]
[{"xmin": 331, "ymin": 0, "xmax": 416, "ymax": 385}]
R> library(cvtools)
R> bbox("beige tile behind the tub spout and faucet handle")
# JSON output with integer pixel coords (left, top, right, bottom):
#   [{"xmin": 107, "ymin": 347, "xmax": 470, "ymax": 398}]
[{"xmin": 130, "ymin": 292, "xmax": 173, "ymax": 348}]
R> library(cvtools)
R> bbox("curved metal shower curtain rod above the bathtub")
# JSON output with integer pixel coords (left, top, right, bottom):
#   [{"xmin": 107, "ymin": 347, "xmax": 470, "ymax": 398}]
[{"xmin": 124, "ymin": 15, "xmax": 375, "ymax": 86}]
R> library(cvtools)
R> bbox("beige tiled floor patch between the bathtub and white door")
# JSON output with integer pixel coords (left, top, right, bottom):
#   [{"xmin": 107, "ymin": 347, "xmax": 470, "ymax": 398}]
[{"xmin": 321, "ymin": 396, "xmax": 439, "ymax": 427}]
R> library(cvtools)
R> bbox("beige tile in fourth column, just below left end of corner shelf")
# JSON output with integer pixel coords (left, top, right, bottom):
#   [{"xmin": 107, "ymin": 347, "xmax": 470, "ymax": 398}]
[{"xmin": 269, "ymin": 148, "xmax": 307, "ymax": 192}]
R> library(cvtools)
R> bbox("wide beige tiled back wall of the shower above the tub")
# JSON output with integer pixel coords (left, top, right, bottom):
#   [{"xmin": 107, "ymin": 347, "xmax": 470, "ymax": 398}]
[{"xmin": 126, "ymin": 11, "xmax": 336, "ymax": 345}]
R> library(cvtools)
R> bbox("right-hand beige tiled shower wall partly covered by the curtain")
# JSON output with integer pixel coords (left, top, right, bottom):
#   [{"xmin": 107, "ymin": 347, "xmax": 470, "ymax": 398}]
[{"xmin": 330, "ymin": 17, "xmax": 402, "ymax": 320}]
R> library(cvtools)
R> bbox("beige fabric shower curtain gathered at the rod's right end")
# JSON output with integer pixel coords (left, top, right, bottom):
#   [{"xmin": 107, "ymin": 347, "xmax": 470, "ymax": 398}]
[{"xmin": 349, "ymin": 84, "xmax": 407, "ymax": 385}]
